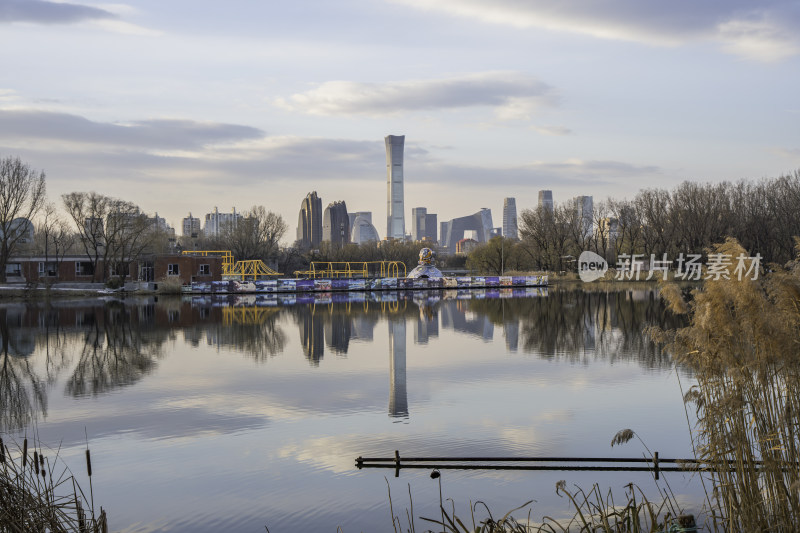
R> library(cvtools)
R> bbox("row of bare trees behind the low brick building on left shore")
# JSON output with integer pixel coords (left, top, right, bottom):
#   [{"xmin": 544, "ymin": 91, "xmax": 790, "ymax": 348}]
[{"xmin": 0, "ymin": 157, "xmax": 288, "ymax": 283}]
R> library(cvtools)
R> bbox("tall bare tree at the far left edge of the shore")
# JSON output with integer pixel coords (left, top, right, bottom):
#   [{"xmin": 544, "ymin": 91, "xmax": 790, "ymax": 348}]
[{"xmin": 0, "ymin": 157, "xmax": 45, "ymax": 283}]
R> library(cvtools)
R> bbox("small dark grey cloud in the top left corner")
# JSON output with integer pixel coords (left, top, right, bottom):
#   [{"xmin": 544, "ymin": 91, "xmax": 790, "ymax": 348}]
[{"xmin": 0, "ymin": 0, "xmax": 116, "ymax": 24}]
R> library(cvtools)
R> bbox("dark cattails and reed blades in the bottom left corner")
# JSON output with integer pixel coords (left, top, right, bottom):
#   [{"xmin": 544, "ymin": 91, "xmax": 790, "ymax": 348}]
[{"xmin": 0, "ymin": 438, "xmax": 108, "ymax": 533}]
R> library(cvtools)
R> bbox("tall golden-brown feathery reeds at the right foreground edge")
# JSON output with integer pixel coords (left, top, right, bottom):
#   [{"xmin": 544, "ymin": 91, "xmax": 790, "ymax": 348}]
[{"xmin": 650, "ymin": 239, "xmax": 800, "ymax": 532}]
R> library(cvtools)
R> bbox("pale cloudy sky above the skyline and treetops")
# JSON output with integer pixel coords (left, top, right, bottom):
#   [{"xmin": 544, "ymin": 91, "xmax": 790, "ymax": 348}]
[{"xmin": 0, "ymin": 0, "xmax": 800, "ymax": 244}]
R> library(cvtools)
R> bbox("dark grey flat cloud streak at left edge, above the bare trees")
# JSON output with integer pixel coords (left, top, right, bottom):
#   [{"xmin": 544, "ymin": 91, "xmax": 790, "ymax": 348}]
[{"xmin": 0, "ymin": 110, "xmax": 264, "ymax": 150}]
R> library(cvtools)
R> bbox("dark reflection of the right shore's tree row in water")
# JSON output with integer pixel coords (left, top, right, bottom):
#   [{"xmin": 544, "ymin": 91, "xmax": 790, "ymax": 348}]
[{"xmin": 468, "ymin": 289, "xmax": 681, "ymax": 368}]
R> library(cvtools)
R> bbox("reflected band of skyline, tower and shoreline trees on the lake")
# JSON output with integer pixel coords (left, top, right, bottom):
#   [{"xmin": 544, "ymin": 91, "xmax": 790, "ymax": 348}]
[{"xmin": 0, "ymin": 288, "xmax": 681, "ymax": 430}]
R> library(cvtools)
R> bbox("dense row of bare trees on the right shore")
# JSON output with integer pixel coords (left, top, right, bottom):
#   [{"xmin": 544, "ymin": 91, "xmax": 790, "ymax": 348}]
[{"xmin": 520, "ymin": 172, "xmax": 800, "ymax": 270}]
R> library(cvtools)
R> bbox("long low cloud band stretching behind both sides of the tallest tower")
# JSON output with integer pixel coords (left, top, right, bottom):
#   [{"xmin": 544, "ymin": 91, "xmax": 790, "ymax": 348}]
[{"xmin": 0, "ymin": 110, "xmax": 661, "ymax": 191}]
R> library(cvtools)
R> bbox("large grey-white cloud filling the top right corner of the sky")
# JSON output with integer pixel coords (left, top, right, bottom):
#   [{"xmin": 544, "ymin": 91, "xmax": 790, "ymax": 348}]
[{"xmin": 395, "ymin": 0, "xmax": 800, "ymax": 61}]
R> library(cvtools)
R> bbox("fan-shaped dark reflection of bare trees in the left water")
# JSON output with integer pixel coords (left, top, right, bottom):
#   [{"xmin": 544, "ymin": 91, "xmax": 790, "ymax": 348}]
[{"xmin": 66, "ymin": 304, "xmax": 168, "ymax": 396}]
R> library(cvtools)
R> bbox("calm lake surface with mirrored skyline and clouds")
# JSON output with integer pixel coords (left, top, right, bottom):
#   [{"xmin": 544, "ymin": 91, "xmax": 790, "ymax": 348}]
[{"xmin": 0, "ymin": 288, "xmax": 701, "ymax": 533}]
